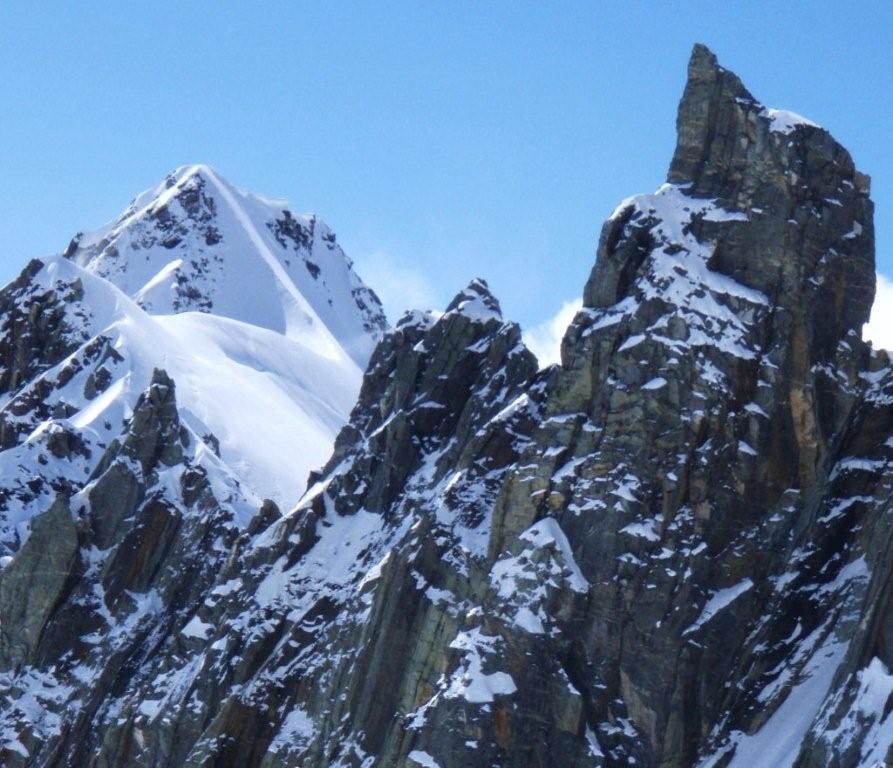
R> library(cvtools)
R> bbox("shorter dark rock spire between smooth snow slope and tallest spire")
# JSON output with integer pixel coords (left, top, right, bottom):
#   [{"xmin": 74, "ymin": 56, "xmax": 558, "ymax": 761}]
[{"xmin": 323, "ymin": 278, "xmax": 537, "ymax": 511}]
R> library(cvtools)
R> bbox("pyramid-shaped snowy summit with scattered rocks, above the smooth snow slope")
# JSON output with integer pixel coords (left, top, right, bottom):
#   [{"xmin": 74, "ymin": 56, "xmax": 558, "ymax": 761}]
[{"xmin": 65, "ymin": 165, "xmax": 386, "ymax": 367}]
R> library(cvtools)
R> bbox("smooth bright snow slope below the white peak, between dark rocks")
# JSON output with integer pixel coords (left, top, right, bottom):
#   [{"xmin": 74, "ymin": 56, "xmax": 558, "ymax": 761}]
[{"xmin": 156, "ymin": 312, "xmax": 362, "ymax": 504}]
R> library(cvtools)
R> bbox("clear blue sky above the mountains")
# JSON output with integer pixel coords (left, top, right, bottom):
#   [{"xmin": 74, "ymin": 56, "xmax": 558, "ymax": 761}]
[{"xmin": 0, "ymin": 0, "xmax": 893, "ymax": 332}]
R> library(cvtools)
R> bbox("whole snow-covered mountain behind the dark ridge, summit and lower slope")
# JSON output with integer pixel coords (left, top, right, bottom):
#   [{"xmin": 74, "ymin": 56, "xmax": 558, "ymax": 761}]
[{"xmin": 0, "ymin": 166, "xmax": 385, "ymax": 520}]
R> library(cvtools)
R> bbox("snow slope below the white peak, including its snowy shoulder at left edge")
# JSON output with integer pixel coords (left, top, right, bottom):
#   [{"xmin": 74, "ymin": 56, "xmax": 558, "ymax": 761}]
[{"xmin": 0, "ymin": 257, "xmax": 362, "ymax": 549}]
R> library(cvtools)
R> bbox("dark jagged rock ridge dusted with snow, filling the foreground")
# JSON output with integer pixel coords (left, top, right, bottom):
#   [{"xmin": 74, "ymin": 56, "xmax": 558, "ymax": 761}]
[{"xmin": 0, "ymin": 45, "xmax": 893, "ymax": 768}]
